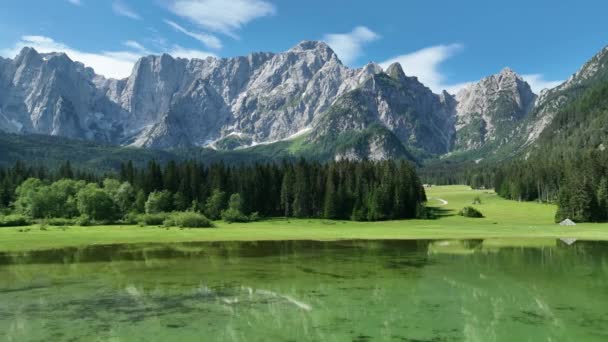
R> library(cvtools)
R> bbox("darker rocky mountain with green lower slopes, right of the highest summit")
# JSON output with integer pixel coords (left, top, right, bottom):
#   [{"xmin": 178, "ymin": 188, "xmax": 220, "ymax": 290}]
[{"xmin": 309, "ymin": 64, "xmax": 454, "ymax": 160}]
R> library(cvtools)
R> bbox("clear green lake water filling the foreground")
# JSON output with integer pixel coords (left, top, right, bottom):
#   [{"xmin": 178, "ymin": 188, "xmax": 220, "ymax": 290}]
[{"xmin": 0, "ymin": 240, "xmax": 608, "ymax": 341}]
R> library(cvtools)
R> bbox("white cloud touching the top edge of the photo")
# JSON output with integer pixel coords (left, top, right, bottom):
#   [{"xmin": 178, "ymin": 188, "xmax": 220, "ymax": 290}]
[{"xmin": 169, "ymin": 0, "xmax": 276, "ymax": 38}]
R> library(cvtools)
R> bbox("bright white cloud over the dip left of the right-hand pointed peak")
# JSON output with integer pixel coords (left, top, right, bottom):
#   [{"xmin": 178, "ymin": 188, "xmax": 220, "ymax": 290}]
[{"xmin": 380, "ymin": 44, "xmax": 466, "ymax": 93}]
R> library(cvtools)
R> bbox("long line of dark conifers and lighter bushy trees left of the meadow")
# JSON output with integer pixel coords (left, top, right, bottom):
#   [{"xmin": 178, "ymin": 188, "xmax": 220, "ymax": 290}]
[{"xmin": 0, "ymin": 159, "xmax": 426, "ymax": 221}]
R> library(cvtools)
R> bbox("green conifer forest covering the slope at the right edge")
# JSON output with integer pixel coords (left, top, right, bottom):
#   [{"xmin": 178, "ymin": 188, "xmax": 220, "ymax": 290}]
[{"xmin": 421, "ymin": 76, "xmax": 608, "ymax": 222}]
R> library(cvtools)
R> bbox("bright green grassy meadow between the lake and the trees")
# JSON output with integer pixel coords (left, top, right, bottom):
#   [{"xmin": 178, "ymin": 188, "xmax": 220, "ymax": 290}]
[{"xmin": 0, "ymin": 186, "xmax": 608, "ymax": 252}]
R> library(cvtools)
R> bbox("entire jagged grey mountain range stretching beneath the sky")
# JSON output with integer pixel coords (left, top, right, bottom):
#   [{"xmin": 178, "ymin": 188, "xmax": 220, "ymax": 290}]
[{"xmin": 0, "ymin": 41, "xmax": 608, "ymax": 161}]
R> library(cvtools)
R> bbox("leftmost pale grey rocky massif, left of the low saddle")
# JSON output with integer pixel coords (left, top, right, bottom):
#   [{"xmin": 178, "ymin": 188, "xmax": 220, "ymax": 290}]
[{"xmin": 0, "ymin": 48, "xmax": 116, "ymax": 139}]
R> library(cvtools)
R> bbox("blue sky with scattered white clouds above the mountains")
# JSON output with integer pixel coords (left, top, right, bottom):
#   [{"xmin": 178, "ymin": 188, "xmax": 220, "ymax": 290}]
[{"xmin": 0, "ymin": 0, "xmax": 608, "ymax": 92}]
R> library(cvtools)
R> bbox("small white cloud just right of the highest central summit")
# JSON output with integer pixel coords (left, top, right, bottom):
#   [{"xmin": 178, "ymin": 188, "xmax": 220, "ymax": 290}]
[{"xmin": 323, "ymin": 26, "xmax": 380, "ymax": 65}]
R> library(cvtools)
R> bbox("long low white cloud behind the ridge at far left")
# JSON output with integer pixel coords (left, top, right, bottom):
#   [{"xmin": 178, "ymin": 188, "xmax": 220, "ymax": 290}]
[{"xmin": 0, "ymin": 36, "xmax": 215, "ymax": 79}]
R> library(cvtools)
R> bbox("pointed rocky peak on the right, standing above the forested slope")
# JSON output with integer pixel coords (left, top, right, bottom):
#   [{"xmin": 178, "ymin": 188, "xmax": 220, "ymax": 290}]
[{"xmin": 454, "ymin": 68, "xmax": 536, "ymax": 151}]
